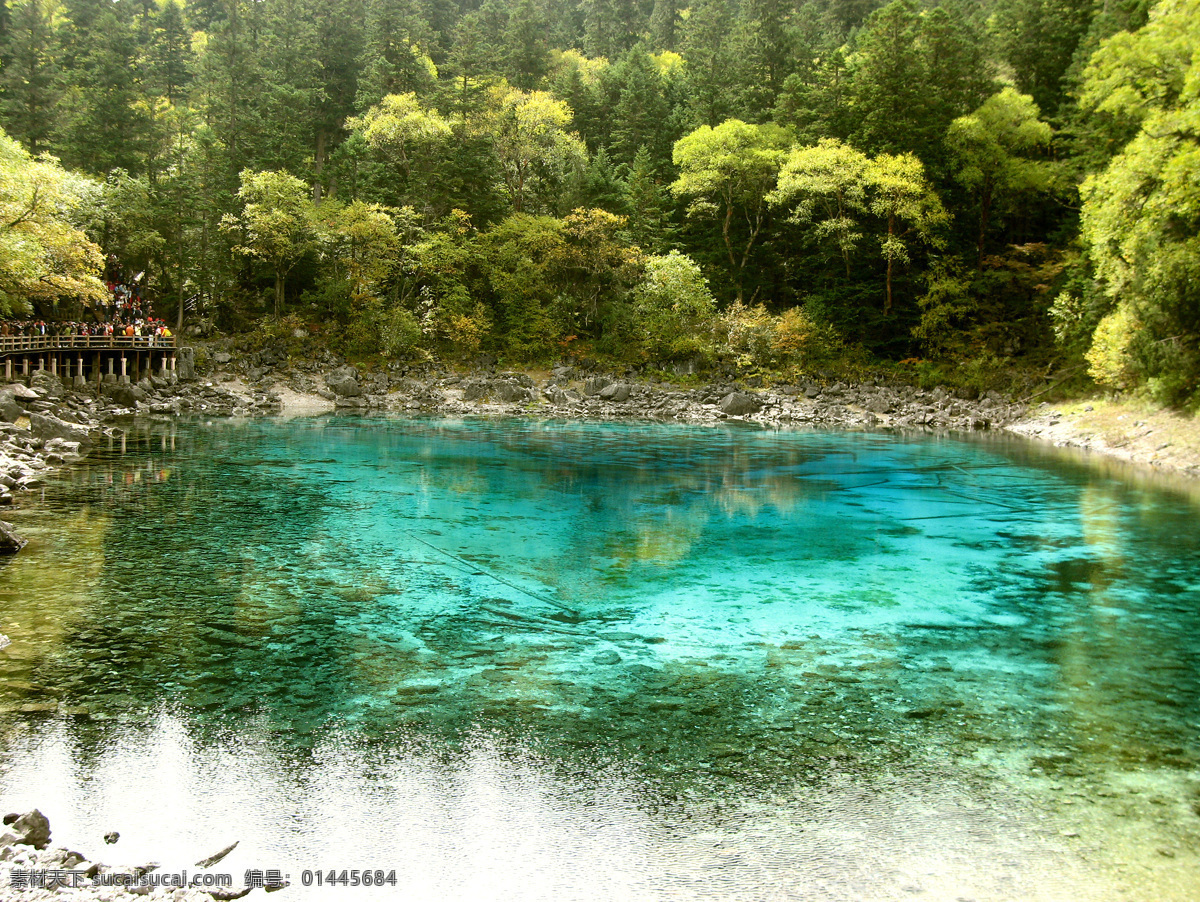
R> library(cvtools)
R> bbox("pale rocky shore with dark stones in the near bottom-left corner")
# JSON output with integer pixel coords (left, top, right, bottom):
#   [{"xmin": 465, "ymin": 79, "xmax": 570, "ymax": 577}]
[{"xmin": 0, "ymin": 808, "xmax": 265, "ymax": 902}]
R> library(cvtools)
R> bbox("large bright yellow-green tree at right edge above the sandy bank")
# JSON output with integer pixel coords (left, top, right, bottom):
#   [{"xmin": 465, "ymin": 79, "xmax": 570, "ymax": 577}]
[{"xmin": 1081, "ymin": 0, "xmax": 1200, "ymax": 403}]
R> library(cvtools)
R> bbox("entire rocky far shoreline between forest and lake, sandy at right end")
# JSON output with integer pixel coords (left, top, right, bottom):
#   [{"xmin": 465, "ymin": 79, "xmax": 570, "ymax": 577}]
[{"xmin": 0, "ymin": 355, "xmax": 1200, "ymax": 553}]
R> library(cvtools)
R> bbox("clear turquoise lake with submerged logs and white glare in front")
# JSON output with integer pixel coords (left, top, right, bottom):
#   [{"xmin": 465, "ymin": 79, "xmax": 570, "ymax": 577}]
[{"xmin": 0, "ymin": 417, "xmax": 1200, "ymax": 902}]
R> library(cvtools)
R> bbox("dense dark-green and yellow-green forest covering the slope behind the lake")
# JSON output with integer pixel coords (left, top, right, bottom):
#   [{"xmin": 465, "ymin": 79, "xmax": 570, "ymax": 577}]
[{"xmin": 0, "ymin": 0, "xmax": 1200, "ymax": 405}]
